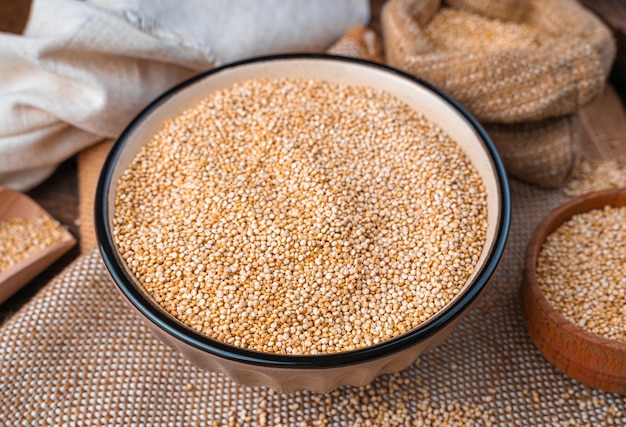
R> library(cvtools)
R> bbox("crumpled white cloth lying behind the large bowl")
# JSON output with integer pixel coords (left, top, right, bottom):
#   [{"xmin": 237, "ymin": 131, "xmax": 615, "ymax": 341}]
[{"xmin": 0, "ymin": 0, "xmax": 369, "ymax": 190}]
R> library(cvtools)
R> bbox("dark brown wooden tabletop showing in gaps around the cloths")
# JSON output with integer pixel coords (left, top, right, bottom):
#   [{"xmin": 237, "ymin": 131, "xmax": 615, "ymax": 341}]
[{"xmin": 0, "ymin": 0, "xmax": 626, "ymax": 324}]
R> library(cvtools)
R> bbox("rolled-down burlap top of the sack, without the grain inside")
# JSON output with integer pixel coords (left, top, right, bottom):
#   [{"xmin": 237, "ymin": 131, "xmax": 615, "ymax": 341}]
[{"xmin": 381, "ymin": 0, "xmax": 615, "ymax": 123}]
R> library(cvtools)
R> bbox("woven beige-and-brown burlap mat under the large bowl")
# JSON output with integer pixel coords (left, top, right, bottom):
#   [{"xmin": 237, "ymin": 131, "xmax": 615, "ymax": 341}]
[{"xmin": 0, "ymin": 182, "xmax": 626, "ymax": 426}]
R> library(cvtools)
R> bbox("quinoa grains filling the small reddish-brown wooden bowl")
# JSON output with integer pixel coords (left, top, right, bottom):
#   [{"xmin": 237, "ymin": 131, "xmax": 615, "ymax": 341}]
[{"xmin": 537, "ymin": 206, "xmax": 626, "ymax": 342}]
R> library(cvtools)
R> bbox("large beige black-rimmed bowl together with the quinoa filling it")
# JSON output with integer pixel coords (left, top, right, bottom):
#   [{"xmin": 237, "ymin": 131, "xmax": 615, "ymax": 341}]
[{"xmin": 96, "ymin": 55, "xmax": 510, "ymax": 391}]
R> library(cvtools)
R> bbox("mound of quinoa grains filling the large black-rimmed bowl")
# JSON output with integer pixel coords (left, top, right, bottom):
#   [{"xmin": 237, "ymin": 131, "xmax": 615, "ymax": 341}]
[{"xmin": 113, "ymin": 79, "xmax": 487, "ymax": 354}]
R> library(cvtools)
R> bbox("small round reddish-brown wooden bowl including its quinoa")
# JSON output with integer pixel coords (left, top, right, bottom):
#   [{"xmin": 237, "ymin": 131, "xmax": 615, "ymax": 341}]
[{"xmin": 522, "ymin": 188, "xmax": 626, "ymax": 394}]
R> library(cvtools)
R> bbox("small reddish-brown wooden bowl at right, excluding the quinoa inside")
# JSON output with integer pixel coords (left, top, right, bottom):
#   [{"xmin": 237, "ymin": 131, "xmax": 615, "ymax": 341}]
[{"xmin": 522, "ymin": 188, "xmax": 626, "ymax": 395}]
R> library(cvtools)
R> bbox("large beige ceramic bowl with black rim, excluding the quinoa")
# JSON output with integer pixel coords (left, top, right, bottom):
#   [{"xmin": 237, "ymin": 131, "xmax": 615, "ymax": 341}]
[{"xmin": 95, "ymin": 55, "xmax": 510, "ymax": 392}]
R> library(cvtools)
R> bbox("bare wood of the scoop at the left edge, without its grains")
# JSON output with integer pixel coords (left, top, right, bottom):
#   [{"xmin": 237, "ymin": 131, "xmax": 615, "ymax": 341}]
[{"xmin": 0, "ymin": 187, "xmax": 76, "ymax": 304}]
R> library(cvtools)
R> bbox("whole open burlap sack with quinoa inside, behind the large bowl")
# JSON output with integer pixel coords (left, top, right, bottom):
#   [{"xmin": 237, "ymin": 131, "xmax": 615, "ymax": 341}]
[{"xmin": 381, "ymin": 0, "xmax": 615, "ymax": 187}]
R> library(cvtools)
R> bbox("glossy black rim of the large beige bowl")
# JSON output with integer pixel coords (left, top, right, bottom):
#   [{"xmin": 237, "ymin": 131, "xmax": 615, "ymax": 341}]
[{"xmin": 94, "ymin": 54, "xmax": 511, "ymax": 369}]
